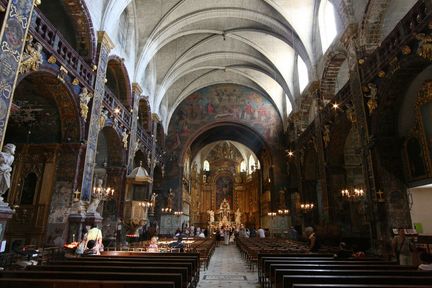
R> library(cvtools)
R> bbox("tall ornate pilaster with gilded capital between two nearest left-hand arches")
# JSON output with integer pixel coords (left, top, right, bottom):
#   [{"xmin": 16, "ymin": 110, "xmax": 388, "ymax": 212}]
[{"xmin": 81, "ymin": 31, "xmax": 114, "ymax": 201}]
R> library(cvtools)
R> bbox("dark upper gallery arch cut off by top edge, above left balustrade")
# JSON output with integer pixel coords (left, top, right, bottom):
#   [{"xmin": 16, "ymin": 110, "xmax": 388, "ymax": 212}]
[{"xmin": 39, "ymin": 0, "xmax": 96, "ymax": 63}]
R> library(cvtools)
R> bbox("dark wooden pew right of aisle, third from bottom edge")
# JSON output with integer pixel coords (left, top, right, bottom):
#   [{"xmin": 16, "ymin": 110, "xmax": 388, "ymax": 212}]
[{"xmin": 272, "ymin": 269, "xmax": 432, "ymax": 288}]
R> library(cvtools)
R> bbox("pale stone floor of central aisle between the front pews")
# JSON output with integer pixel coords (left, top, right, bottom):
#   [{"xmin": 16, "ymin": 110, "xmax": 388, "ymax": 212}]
[{"xmin": 198, "ymin": 244, "xmax": 260, "ymax": 288}]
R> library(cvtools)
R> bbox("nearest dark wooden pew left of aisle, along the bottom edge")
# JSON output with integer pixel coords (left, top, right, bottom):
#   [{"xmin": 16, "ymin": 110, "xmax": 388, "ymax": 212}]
[{"xmin": 0, "ymin": 278, "xmax": 175, "ymax": 288}]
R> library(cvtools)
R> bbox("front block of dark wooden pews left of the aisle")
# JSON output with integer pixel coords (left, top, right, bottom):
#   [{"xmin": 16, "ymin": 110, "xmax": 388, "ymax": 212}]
[{"xmin": 0, "ymin": 252, "xmax": 200, "ymax": 288}]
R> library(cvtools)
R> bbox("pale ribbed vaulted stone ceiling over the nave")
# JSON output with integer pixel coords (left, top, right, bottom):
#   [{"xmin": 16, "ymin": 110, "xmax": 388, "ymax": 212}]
[{"xmin": 86, "ymin": 0, "xmax": 415, "ymax": 127}]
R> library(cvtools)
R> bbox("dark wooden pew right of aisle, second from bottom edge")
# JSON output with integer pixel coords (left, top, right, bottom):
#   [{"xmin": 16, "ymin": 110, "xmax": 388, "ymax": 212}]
[{"xmin": 282, "ymin": 275, "xmax": 432, "ymax": 288}]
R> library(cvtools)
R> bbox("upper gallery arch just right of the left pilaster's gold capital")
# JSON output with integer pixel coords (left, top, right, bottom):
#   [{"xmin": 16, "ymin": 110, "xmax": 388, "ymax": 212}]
[{"xmin": 105, "ymin": 56, "xmax": 132, "ymax": 108}]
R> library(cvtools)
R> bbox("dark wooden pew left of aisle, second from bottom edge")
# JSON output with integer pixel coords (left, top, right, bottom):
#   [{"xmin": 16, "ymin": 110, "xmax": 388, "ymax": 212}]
[{"xmin": 0, "ymin": 270, "xmax": 183, "ymax": 288}]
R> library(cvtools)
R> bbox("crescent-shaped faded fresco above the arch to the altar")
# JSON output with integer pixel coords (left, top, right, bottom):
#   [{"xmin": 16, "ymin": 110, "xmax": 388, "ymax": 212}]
[{"xmin": 168, "ymin": 84, "xmax": 282, "ymax": 149}]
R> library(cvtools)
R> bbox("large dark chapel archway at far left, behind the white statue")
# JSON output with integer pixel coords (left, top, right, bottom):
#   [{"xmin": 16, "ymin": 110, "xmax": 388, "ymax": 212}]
[{"xmin": 5, "ymin": 71, "xmax": 83, "ymax": 244}]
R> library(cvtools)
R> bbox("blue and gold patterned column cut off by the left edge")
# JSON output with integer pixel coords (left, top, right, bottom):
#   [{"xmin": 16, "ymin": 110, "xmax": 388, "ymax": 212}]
[{"xmin": 0, "ymin": 0, "xmax": 39, "ymax": 147}]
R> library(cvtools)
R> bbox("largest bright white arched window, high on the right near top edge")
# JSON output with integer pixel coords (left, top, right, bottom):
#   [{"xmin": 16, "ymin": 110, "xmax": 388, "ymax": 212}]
[{"xmin": 319, "ymin": 0, "xmax": 337, "ymax": 53}]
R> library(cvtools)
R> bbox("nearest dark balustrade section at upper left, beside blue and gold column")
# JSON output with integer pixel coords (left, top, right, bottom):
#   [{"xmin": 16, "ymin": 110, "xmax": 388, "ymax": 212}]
[{"xmin": 29, "ymin": 9, "xmax": 95, "ymax": 90}]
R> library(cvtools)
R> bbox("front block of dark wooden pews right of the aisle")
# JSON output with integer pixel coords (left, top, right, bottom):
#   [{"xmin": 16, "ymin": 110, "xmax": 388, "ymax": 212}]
[{"xmin": 258, "ymin": 253, "xmax": 432, "ymax": 288}]
